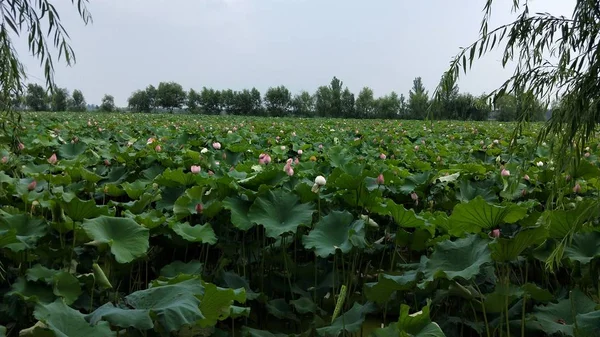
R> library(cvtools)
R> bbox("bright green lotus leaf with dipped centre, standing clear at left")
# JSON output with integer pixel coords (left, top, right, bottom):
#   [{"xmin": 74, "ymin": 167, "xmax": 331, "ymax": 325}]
[{"xmin": 82, "ymin": 216, "xmax": 150, "ymax": 263}]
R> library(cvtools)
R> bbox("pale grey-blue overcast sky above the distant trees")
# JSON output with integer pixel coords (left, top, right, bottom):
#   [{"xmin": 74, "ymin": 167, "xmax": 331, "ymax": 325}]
[{"xmin": 15, "ymin": 0, "xmax": 575, "ymax": 106}]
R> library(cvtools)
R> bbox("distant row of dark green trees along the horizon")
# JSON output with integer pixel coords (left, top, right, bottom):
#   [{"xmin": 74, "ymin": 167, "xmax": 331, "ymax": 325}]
[{"xmin": 15, "ymin": 77, "xmax": 546, "ymax": 121}]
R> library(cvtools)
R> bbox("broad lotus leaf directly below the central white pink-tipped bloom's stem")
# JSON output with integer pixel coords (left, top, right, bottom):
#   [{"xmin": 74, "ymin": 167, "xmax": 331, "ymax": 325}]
[{"xmin": 302, "ymin": 211, "xmax": 366, "ymax": 257}]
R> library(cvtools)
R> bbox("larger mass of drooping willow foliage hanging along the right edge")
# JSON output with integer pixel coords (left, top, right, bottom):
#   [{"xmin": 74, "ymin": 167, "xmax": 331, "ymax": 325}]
[{"xmin": 434, "ymin": 0, "xmax": 600, "ymax": 268}]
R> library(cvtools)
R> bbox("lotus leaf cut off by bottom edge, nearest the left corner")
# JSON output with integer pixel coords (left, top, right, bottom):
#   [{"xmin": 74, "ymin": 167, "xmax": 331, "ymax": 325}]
[{"xmin": 33, "ymin": 300, "xmax": 117, "ymax": 337}]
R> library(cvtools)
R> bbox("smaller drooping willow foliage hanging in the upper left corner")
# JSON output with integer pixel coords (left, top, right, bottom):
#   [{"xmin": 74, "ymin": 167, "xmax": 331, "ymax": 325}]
[{"xmin": 0, "ymin": 0, "xmax": 92, "ymax": 146}]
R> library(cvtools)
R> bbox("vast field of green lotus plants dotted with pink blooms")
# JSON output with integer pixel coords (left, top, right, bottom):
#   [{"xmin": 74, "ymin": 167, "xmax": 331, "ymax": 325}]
[{"xmin": 0, "ymin": 113, "xmax": 600, "ymax": 337}]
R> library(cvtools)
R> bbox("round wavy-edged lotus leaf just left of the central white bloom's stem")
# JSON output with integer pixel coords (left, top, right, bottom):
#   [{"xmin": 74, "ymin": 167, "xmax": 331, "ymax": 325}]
[{"xmin": 248, "ymin": 189, "xmax": 315, "ymax": 238}]
